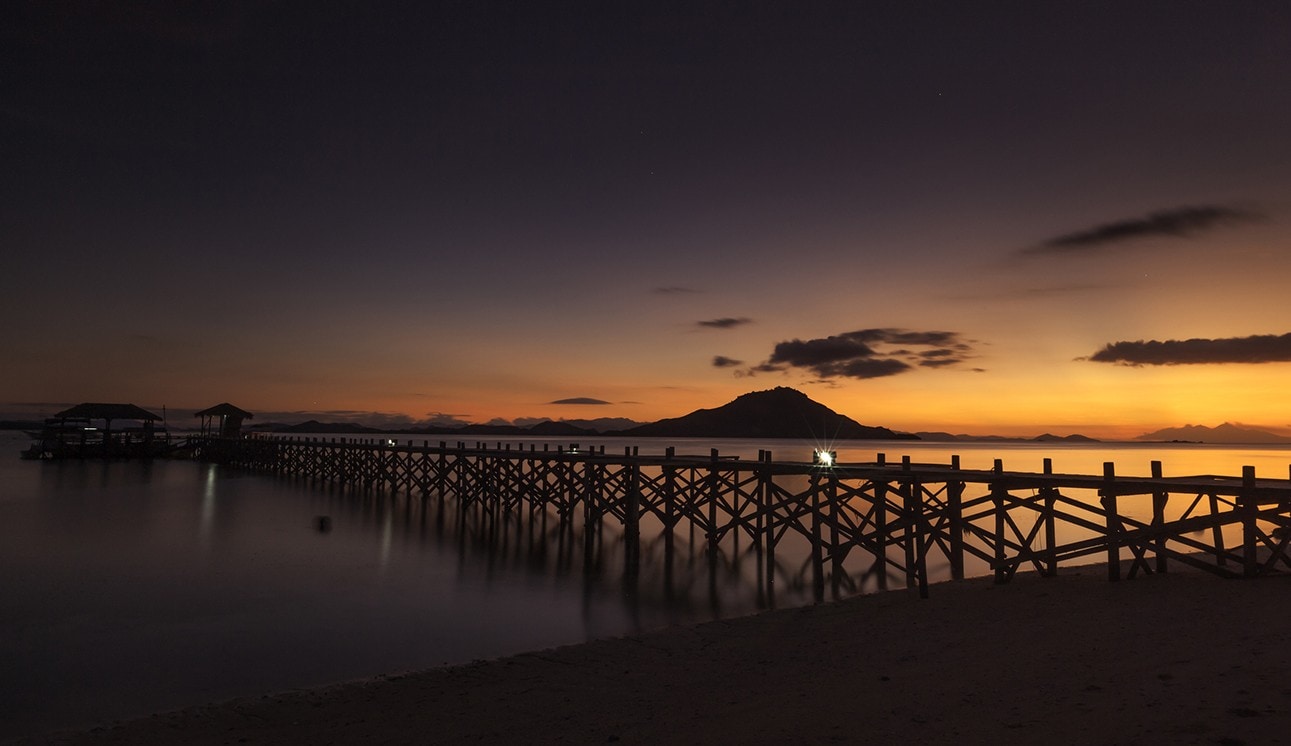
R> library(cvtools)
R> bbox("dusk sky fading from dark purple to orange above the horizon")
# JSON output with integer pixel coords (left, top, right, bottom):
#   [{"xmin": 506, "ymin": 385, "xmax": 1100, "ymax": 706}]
[{"xmin": 0, "ymin": 0, "xmax": 1291, "ymax": 438}]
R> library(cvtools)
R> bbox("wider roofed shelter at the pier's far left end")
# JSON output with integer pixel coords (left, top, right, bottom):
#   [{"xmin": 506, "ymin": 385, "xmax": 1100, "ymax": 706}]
[{"xmin": 22, "ymin": 401, "xmax": 168, "ymax": 458}]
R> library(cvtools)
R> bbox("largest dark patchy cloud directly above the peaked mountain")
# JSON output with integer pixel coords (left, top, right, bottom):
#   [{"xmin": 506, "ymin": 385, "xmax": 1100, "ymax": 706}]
[{"xmin": 737, "ymin": 329, "xmax": 972, "ymax": 381}]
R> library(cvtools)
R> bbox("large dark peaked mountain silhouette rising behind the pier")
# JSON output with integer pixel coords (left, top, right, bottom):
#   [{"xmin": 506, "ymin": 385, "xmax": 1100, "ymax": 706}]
[{"xmin": 618, "ymin": 386, "xmax": 913, "ymax": 441}]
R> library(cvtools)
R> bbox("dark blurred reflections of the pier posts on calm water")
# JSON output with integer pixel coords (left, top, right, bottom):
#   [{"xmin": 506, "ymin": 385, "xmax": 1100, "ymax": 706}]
[{"xmin": 295, "ymin": 469, "xmax": 821, "ymax": 627}]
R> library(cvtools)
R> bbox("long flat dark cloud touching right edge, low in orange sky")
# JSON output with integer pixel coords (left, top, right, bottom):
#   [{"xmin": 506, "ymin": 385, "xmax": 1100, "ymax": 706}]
[{"xmin": 1088, "ymin": 334, "xmax": 1291, "ymax": 367}]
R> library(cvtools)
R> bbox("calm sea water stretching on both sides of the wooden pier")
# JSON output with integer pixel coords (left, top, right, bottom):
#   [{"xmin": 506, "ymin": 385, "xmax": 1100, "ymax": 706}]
[{"xmin": 0, "ymin": 432, "xmax": 1291, "ymax": 738}]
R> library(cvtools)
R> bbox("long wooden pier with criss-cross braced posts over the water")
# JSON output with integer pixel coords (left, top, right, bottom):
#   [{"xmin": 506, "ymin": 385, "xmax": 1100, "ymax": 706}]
[{"xmin": 201, "ymin": 438, "xmax": 1291, "ymax": 599}]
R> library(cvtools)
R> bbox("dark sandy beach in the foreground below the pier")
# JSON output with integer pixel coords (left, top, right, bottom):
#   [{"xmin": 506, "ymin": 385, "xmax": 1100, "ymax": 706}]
[{"xmin": 15, "ymin": 567, "xmax": 1291, "ymax": 745}]
